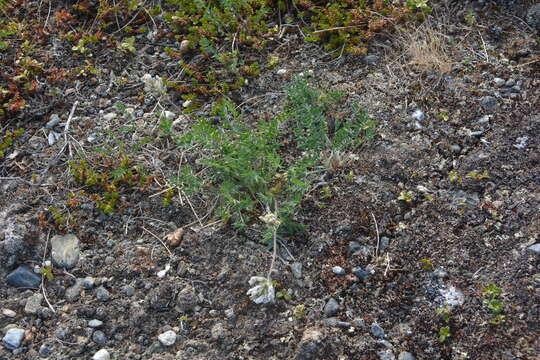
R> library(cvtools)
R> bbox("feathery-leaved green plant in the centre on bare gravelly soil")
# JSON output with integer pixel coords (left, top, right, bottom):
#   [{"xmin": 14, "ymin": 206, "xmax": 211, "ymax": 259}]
[{"xmin": 177, "ymin": 78, "xmax": 375, "ymax": 241}]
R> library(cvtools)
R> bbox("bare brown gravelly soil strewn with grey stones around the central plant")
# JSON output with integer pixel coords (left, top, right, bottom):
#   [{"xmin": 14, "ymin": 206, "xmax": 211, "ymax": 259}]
[{"xmin": 0, "ymin": 1, "xmax": 540, "ymax": 360}]
